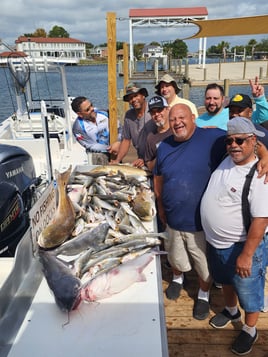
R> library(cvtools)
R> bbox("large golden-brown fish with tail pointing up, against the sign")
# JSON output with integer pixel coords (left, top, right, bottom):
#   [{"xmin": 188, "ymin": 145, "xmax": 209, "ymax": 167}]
[{"xmin": 38, "ymin": 166, "xmax": 75, "ymax": 249}]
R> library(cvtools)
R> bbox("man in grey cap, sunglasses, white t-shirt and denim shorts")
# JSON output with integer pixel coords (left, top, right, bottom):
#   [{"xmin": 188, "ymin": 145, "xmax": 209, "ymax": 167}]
[{"xmin": 201, "ymin": 117, "xmax": 268, "ymax": 355}]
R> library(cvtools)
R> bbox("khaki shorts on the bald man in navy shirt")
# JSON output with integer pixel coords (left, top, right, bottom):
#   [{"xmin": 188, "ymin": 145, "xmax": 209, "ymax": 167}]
[{"xmin": 165, "ymin": 226, "xmax": 211, "ymax": 283}]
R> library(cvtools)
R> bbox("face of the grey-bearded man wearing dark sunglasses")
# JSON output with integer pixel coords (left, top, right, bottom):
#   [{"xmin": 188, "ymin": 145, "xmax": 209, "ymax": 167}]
[{"xmin": 226, "ymin": 134, "xmax": 256, "ymax": 165}]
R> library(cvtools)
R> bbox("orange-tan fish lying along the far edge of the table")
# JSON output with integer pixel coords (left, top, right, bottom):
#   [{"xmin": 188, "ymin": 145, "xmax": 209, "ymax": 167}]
[{"xmin": 84, "ymin": 164, "xmax": 151, "ymax": 181}]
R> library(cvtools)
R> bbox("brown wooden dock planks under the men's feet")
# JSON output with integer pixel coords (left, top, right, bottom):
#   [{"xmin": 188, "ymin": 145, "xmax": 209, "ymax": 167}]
[{"xmin": 162, "ymin": 258, "xmax": 268, "ymax": 357}]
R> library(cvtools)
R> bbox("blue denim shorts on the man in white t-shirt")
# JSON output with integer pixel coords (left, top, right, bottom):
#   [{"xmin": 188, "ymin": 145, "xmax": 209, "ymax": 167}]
[{"xmin": 207, "ymin": 239, "xmax": 267, "ymax": 312}]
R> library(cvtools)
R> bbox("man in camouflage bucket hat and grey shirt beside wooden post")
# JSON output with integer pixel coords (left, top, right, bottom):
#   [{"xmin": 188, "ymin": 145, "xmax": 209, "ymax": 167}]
[{"xmin": 111, "ymin": 83, "xmax": 156, "ymax": 167}]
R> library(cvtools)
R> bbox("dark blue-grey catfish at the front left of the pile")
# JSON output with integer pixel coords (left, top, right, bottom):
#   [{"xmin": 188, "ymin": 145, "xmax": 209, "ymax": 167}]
[{"xmin": 38, "ymin": 249, "xmax": 82, "ymax": 312}]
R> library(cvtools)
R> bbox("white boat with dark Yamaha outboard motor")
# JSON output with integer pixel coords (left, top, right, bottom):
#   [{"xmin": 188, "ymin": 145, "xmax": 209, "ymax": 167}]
[{"xmin": 0, "ymin": 56, "xmax": 88, "ymax": 256}]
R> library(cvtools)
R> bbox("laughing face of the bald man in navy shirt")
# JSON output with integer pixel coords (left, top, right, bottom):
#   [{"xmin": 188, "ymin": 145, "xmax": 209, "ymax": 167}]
[{"xmin": 169, "ymin": 104, "xmax": 196, "ymax": 142}]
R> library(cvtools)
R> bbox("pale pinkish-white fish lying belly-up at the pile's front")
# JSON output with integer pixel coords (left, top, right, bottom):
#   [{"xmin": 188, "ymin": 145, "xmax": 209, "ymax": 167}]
[{"xmin": 80, "ymin": 253, "xmax": 153, "ymax": 302}]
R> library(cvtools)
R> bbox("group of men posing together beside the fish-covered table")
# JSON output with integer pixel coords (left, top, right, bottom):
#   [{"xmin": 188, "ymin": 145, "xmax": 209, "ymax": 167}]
[{"xmin": 72, "ymin": 74, "xmax": 268, "ymax": 355}]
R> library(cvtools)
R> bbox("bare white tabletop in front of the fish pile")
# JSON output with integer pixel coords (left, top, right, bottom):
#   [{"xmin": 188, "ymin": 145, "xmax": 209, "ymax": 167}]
[{"xmin": 8, "ymin": 254, "xmax": 168, "ymax": 357}]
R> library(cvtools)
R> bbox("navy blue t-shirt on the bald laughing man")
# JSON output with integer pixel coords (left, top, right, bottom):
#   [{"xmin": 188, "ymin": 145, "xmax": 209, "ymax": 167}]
[{"xmin": 154, "ymin": 127, "xmax": 226, "ymax": 232}]
